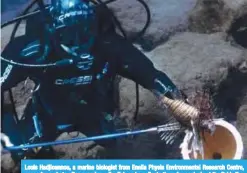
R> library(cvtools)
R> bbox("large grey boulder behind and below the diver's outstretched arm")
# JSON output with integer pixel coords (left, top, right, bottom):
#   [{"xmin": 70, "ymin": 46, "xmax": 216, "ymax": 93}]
[{"xmin": 120, "ymin": 32, "xmax": 245, "ymax": 123}]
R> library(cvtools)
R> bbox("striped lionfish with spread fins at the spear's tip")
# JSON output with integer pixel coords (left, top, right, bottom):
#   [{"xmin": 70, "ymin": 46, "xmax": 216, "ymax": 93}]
[{"xmin": 157, "ymin": 90, "xmax": 216, "ymax": 159}]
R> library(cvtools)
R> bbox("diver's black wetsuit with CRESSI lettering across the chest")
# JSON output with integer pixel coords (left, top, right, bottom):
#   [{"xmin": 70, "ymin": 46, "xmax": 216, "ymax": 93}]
[{"xmin": 1, "ymin": 13, "xmax": 179, "ymax": 159}]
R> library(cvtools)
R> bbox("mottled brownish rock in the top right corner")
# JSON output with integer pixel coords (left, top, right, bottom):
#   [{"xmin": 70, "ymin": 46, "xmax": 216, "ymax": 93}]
[{"xmin": 189, "ymin": 0, "xmax": 247, "ymax": 33}]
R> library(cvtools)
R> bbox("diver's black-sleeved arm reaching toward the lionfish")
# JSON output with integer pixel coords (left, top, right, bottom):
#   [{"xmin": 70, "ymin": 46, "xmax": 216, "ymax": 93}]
[{"xmin": 103, "ymin": 35, "xmax": 182, "ymax": 98}]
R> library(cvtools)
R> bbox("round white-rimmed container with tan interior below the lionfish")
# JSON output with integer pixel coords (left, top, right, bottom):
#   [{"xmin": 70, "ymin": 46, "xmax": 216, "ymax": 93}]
[{"xmin": 180, "ymin": 119, "xmax": 244, "ymax": 160}]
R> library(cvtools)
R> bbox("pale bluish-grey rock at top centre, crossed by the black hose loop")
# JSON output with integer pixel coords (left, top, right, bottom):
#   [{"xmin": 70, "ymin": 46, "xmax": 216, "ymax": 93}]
[{"xmin": 109, "ymin": 0, "xmax": 197, "ymax": 50}]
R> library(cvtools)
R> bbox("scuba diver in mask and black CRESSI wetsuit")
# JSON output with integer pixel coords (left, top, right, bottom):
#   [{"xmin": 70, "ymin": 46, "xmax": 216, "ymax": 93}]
[{"xmin": 1, "ymin": 0, "xmax": 187, "ymax": 160}]
